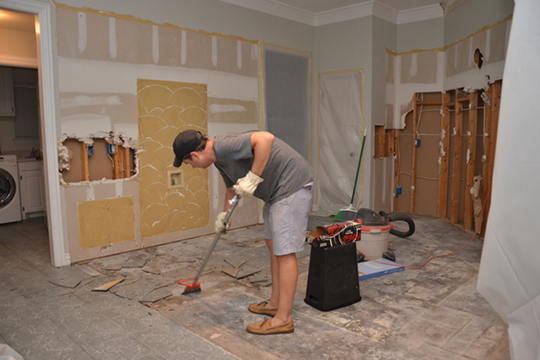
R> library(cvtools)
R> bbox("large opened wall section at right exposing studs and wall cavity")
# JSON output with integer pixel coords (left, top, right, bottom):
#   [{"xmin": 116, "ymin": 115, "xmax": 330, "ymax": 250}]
[{"xmin": 394, "ymin": 81, "xmax": 501, "ymax": 234}]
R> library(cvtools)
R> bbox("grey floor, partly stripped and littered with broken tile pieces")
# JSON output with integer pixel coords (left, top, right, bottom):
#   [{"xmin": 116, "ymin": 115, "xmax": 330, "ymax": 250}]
[{"xmin": 0, "ymin": 216, "xmax": 510, "ymax": 360}]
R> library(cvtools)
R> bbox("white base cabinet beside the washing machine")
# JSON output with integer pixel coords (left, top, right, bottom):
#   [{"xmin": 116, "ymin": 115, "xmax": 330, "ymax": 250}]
[{"xmin": 19, "ymin": 160, "xmax": 45, "ymax": 218}]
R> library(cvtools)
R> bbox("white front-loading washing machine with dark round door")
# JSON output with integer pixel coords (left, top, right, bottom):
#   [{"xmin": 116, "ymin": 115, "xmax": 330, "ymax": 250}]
[{"xmin": 0, "ymin": 155, "xmax": 22, "ymax": 224}]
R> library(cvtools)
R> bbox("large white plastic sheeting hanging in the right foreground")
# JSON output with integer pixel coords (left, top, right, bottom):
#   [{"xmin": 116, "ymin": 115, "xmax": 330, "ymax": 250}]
[{"xmin": 477, "ymin": 0, "xmax": 540, "ymax": 360}]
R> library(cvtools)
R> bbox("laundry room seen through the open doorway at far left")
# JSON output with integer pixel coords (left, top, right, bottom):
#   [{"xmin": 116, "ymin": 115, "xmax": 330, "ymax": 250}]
[{"xmin": 0, "ymin": 9, "xmax": 46, "ymax": 224}]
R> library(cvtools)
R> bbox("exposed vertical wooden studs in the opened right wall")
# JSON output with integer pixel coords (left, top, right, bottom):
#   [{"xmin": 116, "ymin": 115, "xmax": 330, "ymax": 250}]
[{"xmin": 392, "ymin": 84, "xmax": 502, "ymax": 236}]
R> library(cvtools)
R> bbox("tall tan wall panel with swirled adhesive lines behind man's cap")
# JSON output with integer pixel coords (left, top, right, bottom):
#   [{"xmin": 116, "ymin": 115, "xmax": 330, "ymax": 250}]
[{"xmin": 137, "ymin": 79, "xmax": 210, "ymax": 237}]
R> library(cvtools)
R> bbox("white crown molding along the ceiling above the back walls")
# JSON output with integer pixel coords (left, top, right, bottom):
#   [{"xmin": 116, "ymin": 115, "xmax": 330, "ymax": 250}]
[{"xmin": 219, "ymin": 0, "xmax": 444, "ymax": 26}]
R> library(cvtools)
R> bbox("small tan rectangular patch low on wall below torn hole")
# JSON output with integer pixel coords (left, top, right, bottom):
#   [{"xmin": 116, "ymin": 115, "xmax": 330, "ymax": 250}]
[{"xmin": 77, "ymin": 196, "xmax": 135, "ymax": 250}]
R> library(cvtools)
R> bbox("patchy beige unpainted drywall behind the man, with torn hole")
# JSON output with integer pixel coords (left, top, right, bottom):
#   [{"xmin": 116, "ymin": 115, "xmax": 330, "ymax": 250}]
[{"xmin": 56, "ymin": 8, "xmax": 259, "ymax": 261}]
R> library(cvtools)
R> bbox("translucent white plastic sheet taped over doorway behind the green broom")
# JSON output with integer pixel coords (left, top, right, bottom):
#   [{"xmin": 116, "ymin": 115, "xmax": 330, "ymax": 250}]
[{"xmin": 317, "ymin": 71, "xmax": 366, "ymax": 214}]
